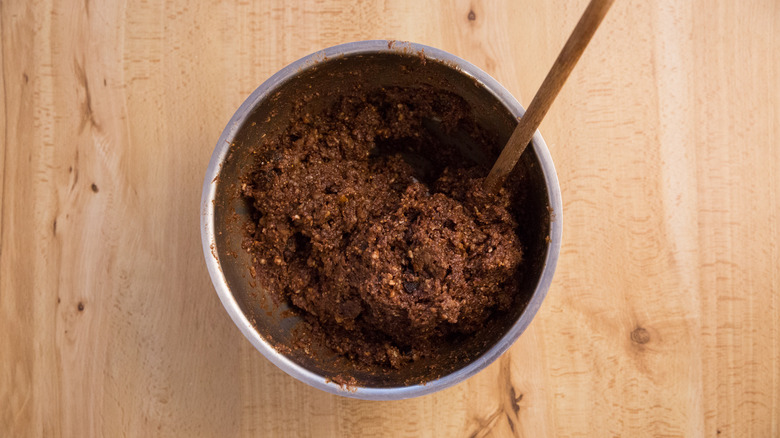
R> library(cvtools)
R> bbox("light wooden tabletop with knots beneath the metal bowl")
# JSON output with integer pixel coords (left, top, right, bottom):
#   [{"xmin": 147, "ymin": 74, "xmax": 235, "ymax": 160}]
[{"xmin": 0, "ymin": 0, "xmax": 780, "ymax": 437}]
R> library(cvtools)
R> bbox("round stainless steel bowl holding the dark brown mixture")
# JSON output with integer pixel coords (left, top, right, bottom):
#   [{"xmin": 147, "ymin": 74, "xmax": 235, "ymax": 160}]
[{"xmin": 201, "ymin": 40, "xmax": 561, "ymax": 400}]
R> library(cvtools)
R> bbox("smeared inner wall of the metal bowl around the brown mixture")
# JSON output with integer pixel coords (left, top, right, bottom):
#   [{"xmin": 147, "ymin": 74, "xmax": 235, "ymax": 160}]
[{"xmin": 213, "ymin": 50, "xmax": 551, "ymax": 388}]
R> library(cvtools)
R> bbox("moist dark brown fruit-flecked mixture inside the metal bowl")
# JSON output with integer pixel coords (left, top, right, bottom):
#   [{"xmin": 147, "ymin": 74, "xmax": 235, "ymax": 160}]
[{"xmin": 242, "ymin": 84, "xmax": 522, "ymax": 368}]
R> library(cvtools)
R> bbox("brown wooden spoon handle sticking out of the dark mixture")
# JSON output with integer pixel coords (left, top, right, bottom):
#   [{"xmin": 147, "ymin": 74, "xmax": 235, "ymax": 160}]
[{"xmin": 485, "ymin": 0, "xmax": 615, "ymax": 192}]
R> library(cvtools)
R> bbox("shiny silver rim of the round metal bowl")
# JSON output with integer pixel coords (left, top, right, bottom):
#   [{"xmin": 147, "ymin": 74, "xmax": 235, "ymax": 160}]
[{"xmin": 200, "ymin": 40, "xmax": 563, "ymax": 400}]
